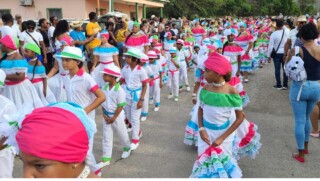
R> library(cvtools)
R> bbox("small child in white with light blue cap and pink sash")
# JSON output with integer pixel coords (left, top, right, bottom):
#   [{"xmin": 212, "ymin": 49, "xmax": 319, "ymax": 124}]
[{"xmin": 167, "ymin": 47, "xmax": 180, "ymax": 102}]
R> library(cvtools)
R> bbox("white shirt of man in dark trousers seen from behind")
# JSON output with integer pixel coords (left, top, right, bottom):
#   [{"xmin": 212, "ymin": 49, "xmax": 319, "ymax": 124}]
[{"xmin": 267, "ymin": 30, "xmax": 288, "ymax": 57}]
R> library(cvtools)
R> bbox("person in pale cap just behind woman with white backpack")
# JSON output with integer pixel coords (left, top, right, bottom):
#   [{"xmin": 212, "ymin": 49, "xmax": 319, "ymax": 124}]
[{"xmin": 284, "ymin": 15, "xmax": 307, "ymax": 58}]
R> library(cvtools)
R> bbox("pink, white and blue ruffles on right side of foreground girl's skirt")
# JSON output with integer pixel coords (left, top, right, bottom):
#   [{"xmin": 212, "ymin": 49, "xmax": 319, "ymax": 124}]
[{"xmin": 233, "ymin": 122, "xmax": 262, "ymax": 160}]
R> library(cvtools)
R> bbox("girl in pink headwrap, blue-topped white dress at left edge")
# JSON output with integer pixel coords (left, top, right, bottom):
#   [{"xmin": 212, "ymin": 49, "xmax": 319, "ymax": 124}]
[{"xmin": 0, "ymin": 35, "xmax": 43, "ymax": 110}]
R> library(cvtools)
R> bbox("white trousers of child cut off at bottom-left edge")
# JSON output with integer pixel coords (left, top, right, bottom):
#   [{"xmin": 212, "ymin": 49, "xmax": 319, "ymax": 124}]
[{"xmin": 0, "ymin": 147, "xmax": 14, "ymax": 178}]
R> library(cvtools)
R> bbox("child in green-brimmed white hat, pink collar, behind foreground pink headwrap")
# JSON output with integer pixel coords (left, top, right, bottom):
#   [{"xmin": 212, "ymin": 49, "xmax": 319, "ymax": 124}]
[{"xmin": 57, "ymin": 46, "xmax": 106, "ymax": 174}]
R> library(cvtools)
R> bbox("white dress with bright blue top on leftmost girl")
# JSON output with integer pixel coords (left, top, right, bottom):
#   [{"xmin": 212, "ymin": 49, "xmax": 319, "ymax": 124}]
[{"xmin": 0, "ymin": 59, "xmax": 44, "ymax": 110}]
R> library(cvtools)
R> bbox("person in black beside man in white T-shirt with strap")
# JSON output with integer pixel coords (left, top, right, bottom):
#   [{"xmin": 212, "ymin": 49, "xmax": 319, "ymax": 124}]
[{"xmin": 39, "ymin": 18, "xmax": 54, "ymax": 73}]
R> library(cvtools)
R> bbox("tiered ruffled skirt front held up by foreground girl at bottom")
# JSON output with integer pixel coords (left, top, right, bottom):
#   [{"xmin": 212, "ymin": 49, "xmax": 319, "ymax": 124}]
[{"xmin": 190, "ymin": 146, "xmax": 242, "ymax": 178}]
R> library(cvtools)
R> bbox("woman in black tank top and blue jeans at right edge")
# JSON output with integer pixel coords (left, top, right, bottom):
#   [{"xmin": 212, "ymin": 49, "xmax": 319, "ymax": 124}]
[{"xmin": 289, "ymin": 23, "xmax": 320, "ymax": 163}]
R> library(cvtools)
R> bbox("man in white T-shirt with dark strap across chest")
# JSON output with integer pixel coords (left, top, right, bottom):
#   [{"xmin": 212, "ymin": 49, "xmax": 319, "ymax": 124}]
[{"xmin": 19, "ymin": 20, "xmax": 48, "ymax": 65}]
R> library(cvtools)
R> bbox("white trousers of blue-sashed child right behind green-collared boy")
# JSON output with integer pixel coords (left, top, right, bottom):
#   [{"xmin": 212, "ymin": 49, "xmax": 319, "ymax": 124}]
[{"xmin": 125, "ymin": 99, "xmax": 141, "ymax": 143}]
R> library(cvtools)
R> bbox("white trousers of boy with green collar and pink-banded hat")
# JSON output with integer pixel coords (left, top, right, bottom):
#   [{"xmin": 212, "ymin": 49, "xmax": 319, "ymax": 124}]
[{"xmin": 102, "ymin": 112, "xmax": 130, "ymax": 158}]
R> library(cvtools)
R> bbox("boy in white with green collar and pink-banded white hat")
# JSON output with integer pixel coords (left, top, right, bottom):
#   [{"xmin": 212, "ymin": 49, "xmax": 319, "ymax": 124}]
[{"xmin": 101, "ymin": 64, "xmax": 131, "ymax": 165}]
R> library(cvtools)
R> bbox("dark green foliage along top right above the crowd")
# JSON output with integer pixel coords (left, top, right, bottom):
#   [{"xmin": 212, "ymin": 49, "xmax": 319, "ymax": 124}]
[{"xmin": 164, "ymin": 0, "xmax": 315, "ymax": 19}]
